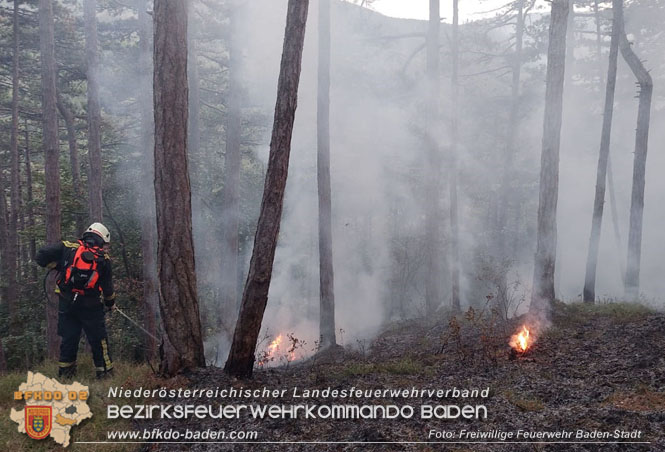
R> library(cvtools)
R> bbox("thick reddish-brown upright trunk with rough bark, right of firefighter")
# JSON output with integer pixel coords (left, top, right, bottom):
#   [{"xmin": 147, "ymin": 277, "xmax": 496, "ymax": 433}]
[{"xmin": 153, "ymin": 0, "xmax": 205, "ymax": 376}]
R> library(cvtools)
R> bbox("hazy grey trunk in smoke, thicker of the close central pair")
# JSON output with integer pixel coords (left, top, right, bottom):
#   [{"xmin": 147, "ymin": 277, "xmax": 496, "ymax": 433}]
[{"xmin": 425, "ymin": 0, "xmax": 443, "ymax": 314}]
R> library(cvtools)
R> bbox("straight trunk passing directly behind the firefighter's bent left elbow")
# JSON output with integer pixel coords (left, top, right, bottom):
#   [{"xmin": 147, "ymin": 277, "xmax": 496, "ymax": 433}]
[{"xmin": 39, "ymin": 0, "xmax": 62, "ymax": 359}]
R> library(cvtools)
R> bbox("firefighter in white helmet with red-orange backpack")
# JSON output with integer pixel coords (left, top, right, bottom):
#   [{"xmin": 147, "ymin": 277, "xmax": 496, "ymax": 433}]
[{"xmin": 35, "ymin": 223, "xmax": 115, "ymax": 378}]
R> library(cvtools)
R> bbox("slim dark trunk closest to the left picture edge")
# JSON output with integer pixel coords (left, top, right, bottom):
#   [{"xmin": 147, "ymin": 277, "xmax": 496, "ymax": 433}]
[{"xmin": 4, "ymin": 0, "xmax": 21, "ymax": 334}]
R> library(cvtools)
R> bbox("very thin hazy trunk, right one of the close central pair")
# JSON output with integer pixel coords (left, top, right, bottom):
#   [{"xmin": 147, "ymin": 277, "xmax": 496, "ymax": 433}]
[{"xmin": 448, "ymin": 0, "xmax": 460, "ymax": 311}]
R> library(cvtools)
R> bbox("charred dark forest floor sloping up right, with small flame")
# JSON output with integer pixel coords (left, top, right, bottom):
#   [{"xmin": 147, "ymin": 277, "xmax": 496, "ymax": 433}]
[{"xmin": 134, "ymin": 303, "xmax": 665, "ymax": 451}]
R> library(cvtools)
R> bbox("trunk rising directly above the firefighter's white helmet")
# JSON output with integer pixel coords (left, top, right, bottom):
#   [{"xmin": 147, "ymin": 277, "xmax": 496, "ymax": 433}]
[{"xmin": 83, "ymin": 0, "xmax": 103, "ymax": 222}]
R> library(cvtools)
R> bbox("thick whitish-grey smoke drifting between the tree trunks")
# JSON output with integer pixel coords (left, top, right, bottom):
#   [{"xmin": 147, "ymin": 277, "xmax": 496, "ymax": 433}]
[{"xmin": 98, "ymin": 0, "xmax": 665, "ymax": 364}]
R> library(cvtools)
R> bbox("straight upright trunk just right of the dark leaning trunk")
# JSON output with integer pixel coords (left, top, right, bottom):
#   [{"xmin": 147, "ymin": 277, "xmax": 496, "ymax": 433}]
[{"xmin": 316, "ymin": 0, "xmax": 337, "ymax": 348}]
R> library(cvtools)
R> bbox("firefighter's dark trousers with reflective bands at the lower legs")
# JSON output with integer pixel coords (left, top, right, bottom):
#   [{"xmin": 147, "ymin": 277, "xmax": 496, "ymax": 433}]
[{"xmin": 58, "ymin": 297, "xmax": 113, "ymax": 376}]
